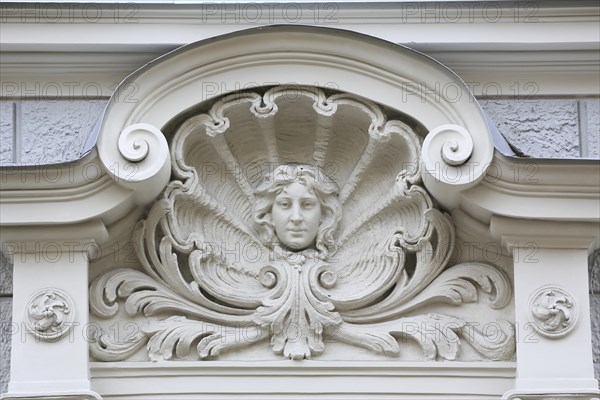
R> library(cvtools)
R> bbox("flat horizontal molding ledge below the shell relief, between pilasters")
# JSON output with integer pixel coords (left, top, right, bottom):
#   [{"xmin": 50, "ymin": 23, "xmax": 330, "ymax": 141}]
[{"xmin": 90, "ymin": 360, "xmax": 515, "ymax": 400}]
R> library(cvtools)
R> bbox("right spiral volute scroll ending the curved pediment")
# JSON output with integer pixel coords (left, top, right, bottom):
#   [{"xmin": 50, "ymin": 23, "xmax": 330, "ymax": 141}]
[{"xmin": 421, "ymin": 124, "xmax": 489, "ymax": 209}]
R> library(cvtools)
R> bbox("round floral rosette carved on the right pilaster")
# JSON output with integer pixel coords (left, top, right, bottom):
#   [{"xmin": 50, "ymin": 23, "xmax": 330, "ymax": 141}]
[{"xmin": 528, "ymin": 285, "xmax": 577, "ymax": 338}]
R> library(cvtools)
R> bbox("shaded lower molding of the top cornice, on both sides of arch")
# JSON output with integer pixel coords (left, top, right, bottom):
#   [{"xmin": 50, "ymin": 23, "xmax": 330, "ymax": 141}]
[{"xmin": 0, "ymin": 49, "xmax": 600, "ymax": 101}]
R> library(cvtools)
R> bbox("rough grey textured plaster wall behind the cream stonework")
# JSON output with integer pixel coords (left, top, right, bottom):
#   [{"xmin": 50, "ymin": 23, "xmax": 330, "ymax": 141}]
[{"xmin": 0, "ymin": 99, "xmax": 600, "ymax": 393}]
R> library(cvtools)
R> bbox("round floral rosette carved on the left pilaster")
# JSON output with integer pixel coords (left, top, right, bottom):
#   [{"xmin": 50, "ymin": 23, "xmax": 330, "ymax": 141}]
[{"xmin": 24, "ymin": 288, "xmax": 75, "ymax": 341}]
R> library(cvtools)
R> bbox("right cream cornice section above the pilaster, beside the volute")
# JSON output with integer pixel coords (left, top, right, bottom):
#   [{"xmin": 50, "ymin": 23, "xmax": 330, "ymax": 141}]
[{"xmin": 461, "ymin": 151, "xmax": 600, "ymax": 223}]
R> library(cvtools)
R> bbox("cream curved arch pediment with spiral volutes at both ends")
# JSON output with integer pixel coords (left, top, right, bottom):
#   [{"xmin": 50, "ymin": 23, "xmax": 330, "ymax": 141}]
[{"xmin": 97, "ymin": 26, "xmax": 493, "ymax": 208}]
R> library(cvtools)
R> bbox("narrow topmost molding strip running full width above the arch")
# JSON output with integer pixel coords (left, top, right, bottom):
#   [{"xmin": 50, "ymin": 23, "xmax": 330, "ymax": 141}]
[{"xmin": 2, "ymin": 0, "xmax": 600, "ymax": 28}]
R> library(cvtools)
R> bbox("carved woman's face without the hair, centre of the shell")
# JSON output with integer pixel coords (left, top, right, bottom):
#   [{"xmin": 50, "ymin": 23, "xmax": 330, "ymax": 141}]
[{"xmin": 271, "ymin": 182, "xmax": 321, "ymax": 250}]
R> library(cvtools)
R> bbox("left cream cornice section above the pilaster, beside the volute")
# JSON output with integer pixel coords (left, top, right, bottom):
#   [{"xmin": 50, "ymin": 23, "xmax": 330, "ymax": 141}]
[{"xmin": 0, "ymin": 152, "xmax": 134, "ymax": 228}]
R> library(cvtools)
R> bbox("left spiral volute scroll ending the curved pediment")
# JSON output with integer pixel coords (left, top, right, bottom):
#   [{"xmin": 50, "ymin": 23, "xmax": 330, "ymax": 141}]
[{"xmin": 101, "ymin": 123, "xmax": 171, "ymax": 203}]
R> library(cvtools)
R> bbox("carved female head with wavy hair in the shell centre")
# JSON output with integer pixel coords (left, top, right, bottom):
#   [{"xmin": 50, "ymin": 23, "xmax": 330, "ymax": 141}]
[{"xmin": 253, "ymin": 164, "xmax": 342, "ymax": 254}]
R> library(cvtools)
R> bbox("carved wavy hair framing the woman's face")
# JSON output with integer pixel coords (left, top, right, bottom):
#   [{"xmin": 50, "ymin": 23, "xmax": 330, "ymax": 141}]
[{"xmin": 253, "ymin": 164, "xmax": 342, "ymax": 255}]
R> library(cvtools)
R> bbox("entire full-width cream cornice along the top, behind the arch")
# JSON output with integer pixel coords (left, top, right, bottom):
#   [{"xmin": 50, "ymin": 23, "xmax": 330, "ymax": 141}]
[{"xmin": 0, "ymin": 2, "xmax": 600, "ymax": 99}]
